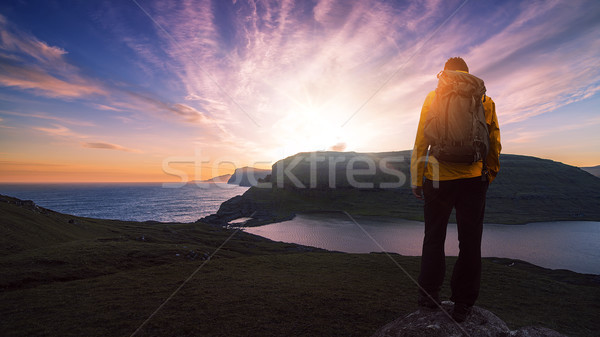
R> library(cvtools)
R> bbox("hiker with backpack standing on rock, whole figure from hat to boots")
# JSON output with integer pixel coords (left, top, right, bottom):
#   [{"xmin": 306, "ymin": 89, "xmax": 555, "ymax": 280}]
[{"xmin": 411, "ymin": 57, "xmax": 501, "ymax": 322}]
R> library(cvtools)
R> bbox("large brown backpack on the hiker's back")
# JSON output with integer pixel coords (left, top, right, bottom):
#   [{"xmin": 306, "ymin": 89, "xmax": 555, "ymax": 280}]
[{"xmin": 424, "ymin": 70, "xmax": 490, "ymax": 164}]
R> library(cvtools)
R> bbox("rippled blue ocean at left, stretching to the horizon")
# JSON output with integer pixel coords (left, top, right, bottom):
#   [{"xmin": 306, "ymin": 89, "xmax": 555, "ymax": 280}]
[{"xmin": 0, "ymin": 183, "xmax": 248, "ymax": 222}]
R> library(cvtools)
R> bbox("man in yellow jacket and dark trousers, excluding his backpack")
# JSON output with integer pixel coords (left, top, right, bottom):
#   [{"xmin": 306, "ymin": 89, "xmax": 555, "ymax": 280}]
[{"xmin": 411, "ymin": 57, "xmax": 501, "ymax": 322}]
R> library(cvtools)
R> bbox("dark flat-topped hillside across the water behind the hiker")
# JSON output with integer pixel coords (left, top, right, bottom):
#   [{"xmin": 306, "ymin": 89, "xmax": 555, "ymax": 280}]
[{"xmin": 204, "ymin": 151, "xmax": 600, "ymax": 225}]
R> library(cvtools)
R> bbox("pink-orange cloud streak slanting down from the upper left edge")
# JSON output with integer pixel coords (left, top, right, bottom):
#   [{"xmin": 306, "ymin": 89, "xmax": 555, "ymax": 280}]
[{"xmin": 0, "ymin": 13, "xmax": 220, "ymax": 131}]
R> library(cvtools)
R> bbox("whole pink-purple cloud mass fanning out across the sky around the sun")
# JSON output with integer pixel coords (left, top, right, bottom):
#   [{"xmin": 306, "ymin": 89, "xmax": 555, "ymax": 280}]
[{"xmin": 12, "ymin": 0, "xmax": 600, "ymax": 159}]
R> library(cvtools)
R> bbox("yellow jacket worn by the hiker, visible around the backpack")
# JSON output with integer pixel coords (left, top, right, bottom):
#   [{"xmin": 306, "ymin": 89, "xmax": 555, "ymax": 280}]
[{"xmin": 410, "ymin": 84, "xmax": 502, "ymax": 187}]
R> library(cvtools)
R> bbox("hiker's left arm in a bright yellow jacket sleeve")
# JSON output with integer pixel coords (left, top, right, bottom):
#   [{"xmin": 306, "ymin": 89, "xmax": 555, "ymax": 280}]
[{"xmin": 410, "ymin": 91, "xmax": 435, "ymax": 199}]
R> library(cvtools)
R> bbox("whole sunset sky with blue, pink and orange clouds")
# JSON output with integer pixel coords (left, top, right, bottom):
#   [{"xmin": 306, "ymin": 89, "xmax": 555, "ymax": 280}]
[{"xmin": 0, "ymin": 0, "xmax": 600, "ymax": 182}]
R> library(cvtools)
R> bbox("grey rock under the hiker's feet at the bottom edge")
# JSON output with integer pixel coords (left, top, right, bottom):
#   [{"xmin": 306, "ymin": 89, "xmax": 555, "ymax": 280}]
[{"xmin": 372, "ymin": 301, "xmax": 566, "ymax": 337}]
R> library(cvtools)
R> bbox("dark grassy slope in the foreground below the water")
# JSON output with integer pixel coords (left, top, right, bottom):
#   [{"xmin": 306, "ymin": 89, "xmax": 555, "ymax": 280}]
[{"xmin": 0, "ymin": 198, "xmax": 600, "ymax": 336}]
